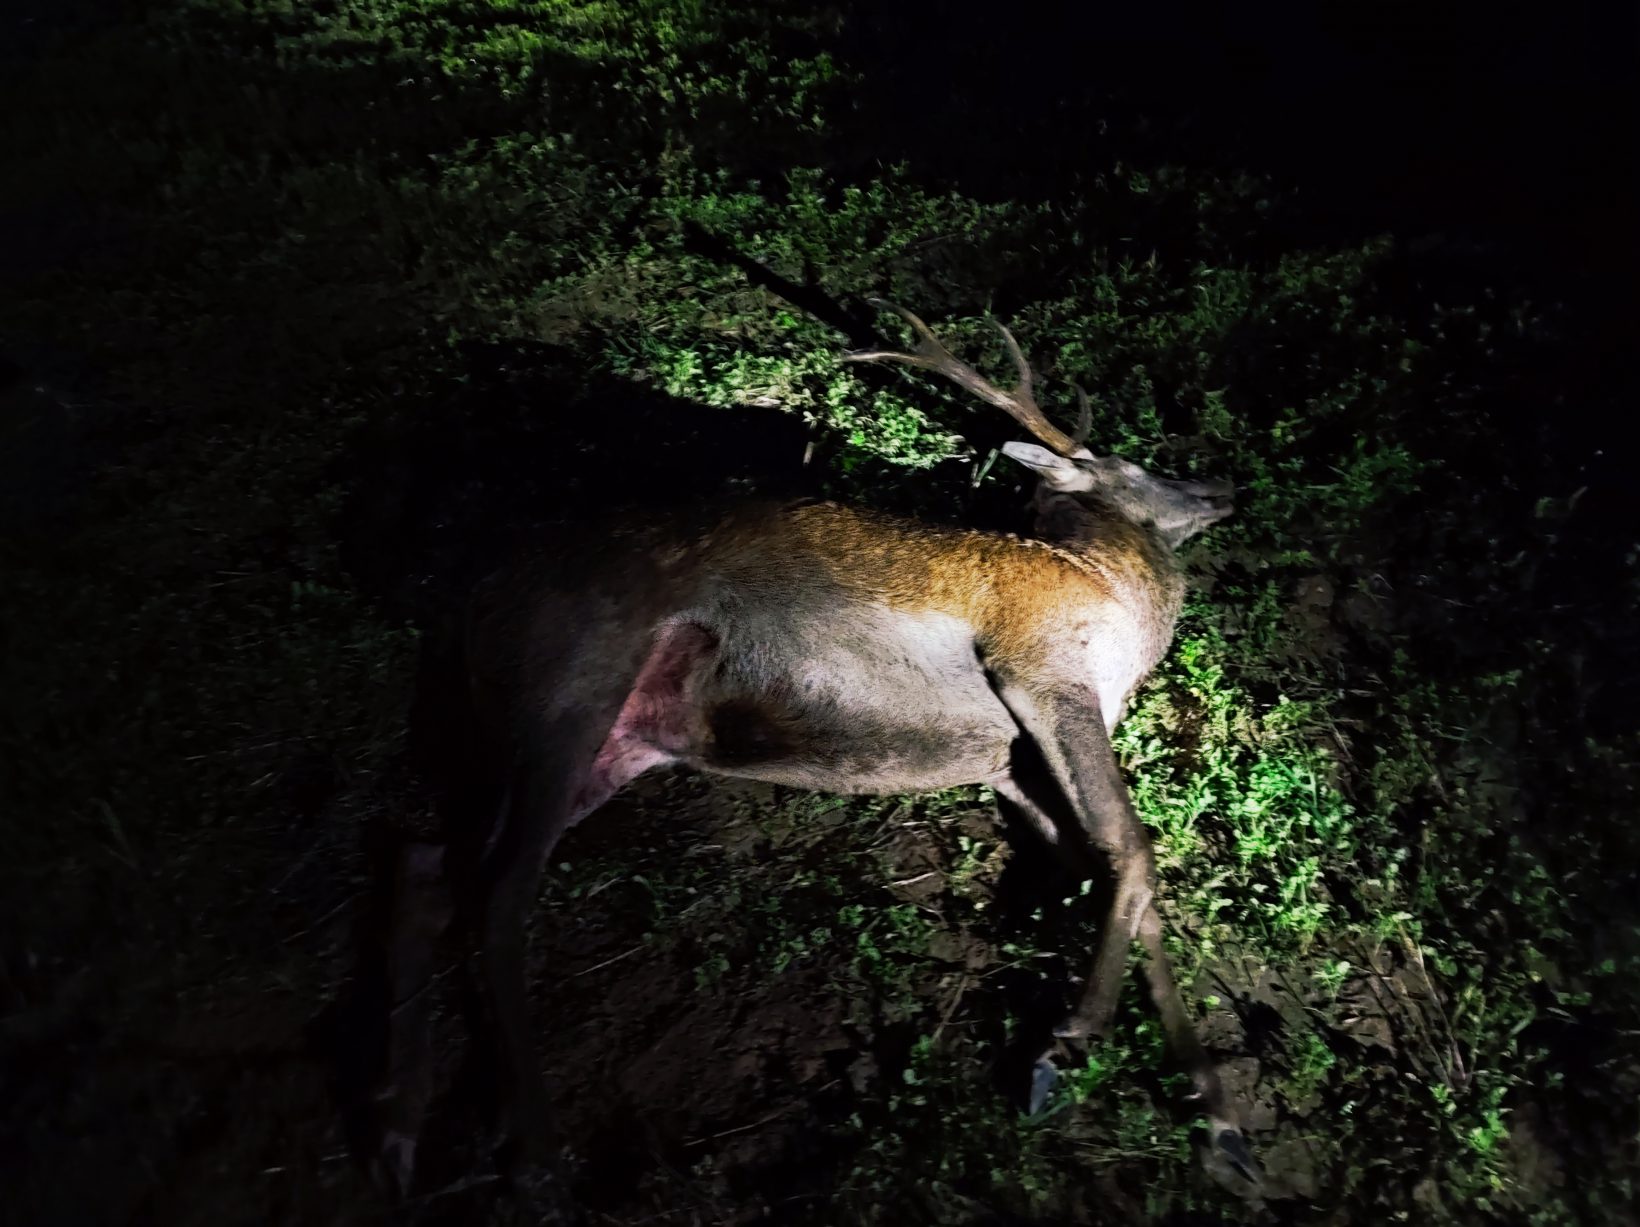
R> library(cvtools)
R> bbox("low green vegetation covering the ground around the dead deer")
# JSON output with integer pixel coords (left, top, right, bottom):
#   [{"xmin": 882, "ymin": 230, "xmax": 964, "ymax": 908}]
[{"xmin": 0, "ymin": 0, "xmax": 1640, "ymax": 1224}]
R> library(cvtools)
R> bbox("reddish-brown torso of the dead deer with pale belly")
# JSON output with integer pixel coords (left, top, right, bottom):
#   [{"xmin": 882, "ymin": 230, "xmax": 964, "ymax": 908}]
[{"xmin": 469, "ymin": 492, "xmax": 1182, "ymax": 810}]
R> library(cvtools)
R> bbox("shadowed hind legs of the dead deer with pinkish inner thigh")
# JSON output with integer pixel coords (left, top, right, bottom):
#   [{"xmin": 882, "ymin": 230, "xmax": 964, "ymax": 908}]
[{"xmin": 369, "ymin": 625, "xmax": 717, "ymax": 1196}]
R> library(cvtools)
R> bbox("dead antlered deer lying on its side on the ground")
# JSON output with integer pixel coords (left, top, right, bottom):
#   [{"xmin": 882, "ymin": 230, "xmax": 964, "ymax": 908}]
[{"xmin": 369, "ymin": 302, "xmax": 1256, "ymax": 1200}]
